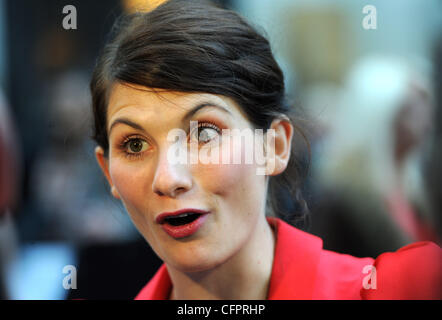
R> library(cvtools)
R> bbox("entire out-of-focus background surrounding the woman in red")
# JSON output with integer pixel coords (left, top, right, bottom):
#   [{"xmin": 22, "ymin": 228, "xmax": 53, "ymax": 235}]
[{"xmin": 0, "ymin": 0, "xmax": 442, "ymax": 299}]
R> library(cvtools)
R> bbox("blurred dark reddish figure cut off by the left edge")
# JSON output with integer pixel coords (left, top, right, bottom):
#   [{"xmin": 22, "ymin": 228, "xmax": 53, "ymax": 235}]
[{"xmin": 0, "ymin": 90, "xmax": 20, "ymax": 300}]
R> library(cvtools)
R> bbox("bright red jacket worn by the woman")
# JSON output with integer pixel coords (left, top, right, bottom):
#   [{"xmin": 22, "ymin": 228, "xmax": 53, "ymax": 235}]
[{"xmin": 135, "ymin": 218, "xmax": 442, "ymax": 300}]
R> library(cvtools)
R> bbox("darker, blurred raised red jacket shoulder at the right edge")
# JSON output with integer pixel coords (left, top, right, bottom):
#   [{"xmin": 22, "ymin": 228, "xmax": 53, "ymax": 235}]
[{"xmin": 361, "ymin": 241, "xmax": 442, "ymax": 300}]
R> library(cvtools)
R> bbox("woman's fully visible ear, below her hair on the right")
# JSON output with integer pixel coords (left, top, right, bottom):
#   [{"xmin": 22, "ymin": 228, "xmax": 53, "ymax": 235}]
[{"xmin": 266, "ymin": 117, "xmax": 293, "ymax": 176}]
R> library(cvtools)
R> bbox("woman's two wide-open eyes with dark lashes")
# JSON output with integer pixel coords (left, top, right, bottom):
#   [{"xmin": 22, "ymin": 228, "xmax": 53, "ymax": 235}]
[{"xmin": 118, "ymin": 121, "xmax": 221, "ymax": 159}]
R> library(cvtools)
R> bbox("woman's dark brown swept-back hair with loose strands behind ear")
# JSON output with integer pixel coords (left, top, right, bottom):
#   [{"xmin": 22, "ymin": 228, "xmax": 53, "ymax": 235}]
[{"xmin": 90, "ymin": 0, "xmax": 307, "ymax": 226}]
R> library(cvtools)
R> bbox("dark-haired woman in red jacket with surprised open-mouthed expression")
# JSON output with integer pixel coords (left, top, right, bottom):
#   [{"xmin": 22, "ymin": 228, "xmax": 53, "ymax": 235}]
[{"xmin": 91, "ymin": 0, "xmax": 440, "ymax": 299}]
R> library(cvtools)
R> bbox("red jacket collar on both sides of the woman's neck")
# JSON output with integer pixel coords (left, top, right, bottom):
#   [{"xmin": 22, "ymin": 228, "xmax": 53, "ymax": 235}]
[{"xmin": 135, "ymin": 218, "xmax": 322, "ymax": 300}]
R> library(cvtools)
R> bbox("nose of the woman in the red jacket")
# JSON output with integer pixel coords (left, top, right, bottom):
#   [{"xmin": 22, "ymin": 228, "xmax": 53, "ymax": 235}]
[{"xmin": 152, "ymin": 150, "xmax": 192, "ymax": 198}]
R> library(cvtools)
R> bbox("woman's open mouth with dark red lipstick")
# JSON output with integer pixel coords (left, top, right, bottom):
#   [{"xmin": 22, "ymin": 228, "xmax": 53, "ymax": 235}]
[{"xmin": 155, "ymin": 209, "xmax": 210, "ymax": 239}]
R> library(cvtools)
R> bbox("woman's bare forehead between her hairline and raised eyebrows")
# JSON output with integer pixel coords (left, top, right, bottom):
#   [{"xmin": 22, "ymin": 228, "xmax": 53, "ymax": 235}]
[{"xmin": 107, "ymin": 83, "xmax": 245, "ymax": 125}]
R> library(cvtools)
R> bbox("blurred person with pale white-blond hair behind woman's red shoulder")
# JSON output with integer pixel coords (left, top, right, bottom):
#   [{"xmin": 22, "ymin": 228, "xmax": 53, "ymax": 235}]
[{"xmin": 311, "ymin": 56, "xmax": 440, "ymax": 256}]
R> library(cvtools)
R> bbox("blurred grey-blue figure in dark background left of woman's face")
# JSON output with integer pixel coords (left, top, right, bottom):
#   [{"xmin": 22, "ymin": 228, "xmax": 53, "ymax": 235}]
[{"xmin": 30, "ymin": 69, "xmax": 136, "ymax": 243}]
